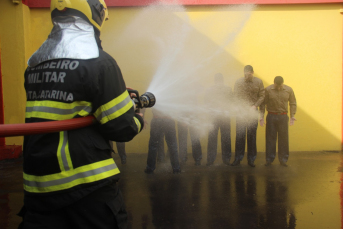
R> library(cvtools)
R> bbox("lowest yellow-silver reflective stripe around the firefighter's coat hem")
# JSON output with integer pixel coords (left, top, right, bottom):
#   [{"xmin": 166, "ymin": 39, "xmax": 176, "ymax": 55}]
[{"xmin": 24, "ymin": 158, "xmax": 120, "ymax": 193}]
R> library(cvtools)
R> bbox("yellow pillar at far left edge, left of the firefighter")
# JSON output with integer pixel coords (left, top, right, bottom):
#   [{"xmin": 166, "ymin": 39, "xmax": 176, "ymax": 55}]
[{"xmin": 0, "ymin": 1, "xmax": 29, "ymax": 145}]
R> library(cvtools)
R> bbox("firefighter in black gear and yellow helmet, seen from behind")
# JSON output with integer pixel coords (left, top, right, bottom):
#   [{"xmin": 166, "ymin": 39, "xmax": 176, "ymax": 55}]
[{"xmin": 19, "ymin": 0, "xmax": 144, "ymax": 229}]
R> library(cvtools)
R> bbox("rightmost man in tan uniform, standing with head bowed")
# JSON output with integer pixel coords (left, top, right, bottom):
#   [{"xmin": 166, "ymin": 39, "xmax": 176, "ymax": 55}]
[{"xmin": 260, "ymin": 76, "xmax": 297, "ymax": 166}]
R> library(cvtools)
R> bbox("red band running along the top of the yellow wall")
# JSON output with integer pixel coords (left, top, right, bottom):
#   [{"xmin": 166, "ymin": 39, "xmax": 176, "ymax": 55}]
[{"xmin": 22, "ymin": 0, "xmax": 343, "ymax": 8}]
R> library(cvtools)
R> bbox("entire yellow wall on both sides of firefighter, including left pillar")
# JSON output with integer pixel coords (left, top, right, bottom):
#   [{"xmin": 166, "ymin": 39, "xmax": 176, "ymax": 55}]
[{"xmin": 0, "ymin": 1, "xmax": 343, "ymax": 152}]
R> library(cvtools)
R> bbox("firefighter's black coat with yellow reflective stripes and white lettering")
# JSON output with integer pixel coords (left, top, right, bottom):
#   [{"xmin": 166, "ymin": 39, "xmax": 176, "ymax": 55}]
[{"xmin": 23, "ymin": 50, "xmax": 144, "ymax": 210}]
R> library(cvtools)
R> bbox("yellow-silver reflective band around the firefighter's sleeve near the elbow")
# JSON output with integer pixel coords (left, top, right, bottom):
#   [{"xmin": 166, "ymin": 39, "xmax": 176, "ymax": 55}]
[{"xmin": 94, "ymin": 91, "xmax": 133, "ymax": 124}]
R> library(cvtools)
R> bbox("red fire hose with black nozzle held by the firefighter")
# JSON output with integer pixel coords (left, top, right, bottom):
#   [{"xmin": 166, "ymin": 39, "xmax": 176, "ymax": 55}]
[{"xmin": 0, "ymin": 89, "xmax": 156, "ymax": 138}]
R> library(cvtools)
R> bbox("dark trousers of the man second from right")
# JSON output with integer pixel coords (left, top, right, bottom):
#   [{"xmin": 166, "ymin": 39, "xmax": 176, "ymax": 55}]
[{"xmin": 235, "ymin": 118, "xmax": 258, "ymax": 162}]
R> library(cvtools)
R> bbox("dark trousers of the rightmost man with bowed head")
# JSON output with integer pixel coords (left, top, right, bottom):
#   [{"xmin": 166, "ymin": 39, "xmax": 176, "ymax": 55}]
[{"xmin": 266, "ymin": 114, "xmax": 289, "ymax": 163}]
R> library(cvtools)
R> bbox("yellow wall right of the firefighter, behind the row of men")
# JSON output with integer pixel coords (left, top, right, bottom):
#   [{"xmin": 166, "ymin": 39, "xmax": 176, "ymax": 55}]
[{"xmin": 103, "ymin": 4, "xmax": 342, "ymax": 152}]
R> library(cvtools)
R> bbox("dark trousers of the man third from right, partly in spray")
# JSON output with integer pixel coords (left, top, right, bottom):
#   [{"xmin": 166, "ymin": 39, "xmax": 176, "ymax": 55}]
[{"xmin": 207, "ymin": 118, "xmax": 231, "ymax": 163}]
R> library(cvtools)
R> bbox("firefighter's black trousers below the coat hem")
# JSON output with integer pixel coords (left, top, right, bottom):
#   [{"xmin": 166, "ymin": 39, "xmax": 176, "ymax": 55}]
[{"xmin": 18, "ymin": 182, "xmax": 127, "ymax": 229}]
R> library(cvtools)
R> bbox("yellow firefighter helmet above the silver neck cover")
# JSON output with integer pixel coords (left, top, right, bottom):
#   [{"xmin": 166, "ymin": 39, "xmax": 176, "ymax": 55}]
[{"xmin": 50, "ymin": 0, "xmax": 108, "ymax": 31}]
